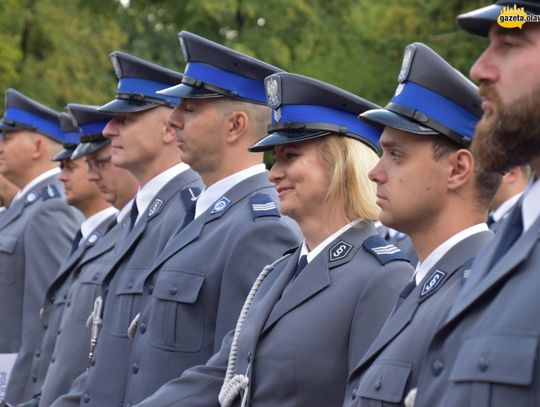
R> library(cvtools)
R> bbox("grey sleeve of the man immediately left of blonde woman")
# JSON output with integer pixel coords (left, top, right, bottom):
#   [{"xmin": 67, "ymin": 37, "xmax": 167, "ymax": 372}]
[{"xmin": 214, "ymin": 218, "xmax": 299, "ymax": 351}]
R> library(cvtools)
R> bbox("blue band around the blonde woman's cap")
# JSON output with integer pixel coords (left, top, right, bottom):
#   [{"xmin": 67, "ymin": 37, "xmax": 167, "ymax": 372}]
[{"xmin": 272, "ymin": 105, "xmax": 382, "ymax": 146}]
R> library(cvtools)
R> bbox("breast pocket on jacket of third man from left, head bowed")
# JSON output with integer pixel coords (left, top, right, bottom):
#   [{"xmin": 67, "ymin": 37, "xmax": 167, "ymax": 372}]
[{"xmin": 70, "ymin": 263, "xmax": 108, "ymax": 323}]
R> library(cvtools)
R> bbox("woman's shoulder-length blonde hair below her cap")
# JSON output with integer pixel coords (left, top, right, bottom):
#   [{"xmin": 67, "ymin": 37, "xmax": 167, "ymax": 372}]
[{"xmin": 319, "ymin": 135, "xmax": 380, "ymax": 221}]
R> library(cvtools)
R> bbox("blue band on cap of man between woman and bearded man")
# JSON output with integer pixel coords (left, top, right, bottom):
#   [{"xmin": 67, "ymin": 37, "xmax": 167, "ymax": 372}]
[{"xmin": 390, "ymin": 82, "xmax": 480, "ymax": 140}]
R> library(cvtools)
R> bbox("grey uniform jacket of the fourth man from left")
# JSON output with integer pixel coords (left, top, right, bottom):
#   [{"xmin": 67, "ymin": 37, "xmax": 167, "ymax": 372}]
[{"xmin": 48, "ymin": 169, "xmax": 202, "ymax": 407}]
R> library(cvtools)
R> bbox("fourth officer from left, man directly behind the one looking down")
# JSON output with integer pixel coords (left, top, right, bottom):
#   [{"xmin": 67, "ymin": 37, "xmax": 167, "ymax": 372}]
[{"xmin": 48, "ymin": 52, "xmax": 202, "ymax": 407}]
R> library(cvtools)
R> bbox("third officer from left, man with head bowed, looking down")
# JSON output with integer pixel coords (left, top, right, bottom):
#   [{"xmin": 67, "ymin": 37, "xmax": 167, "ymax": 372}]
[{"xmin": 34, "ymin": 103, "xmax": 138, "ymax": 406}]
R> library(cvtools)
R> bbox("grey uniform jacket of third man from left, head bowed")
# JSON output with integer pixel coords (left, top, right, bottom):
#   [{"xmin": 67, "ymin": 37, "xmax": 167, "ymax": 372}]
[{"xmin": 39, "ymin": 220, "xmax": 122, "ymax": 406}]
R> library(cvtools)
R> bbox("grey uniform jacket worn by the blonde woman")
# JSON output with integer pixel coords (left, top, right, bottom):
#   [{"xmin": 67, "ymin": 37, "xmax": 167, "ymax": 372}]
[{"xmin": 133, "ymin": 222, "xmax": 413, "ymax": 407}]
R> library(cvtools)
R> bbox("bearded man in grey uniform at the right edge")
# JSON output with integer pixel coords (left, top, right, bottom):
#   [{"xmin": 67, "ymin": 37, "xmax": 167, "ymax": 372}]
[{"xmin": 415, "ymin": 0, "xmax": 540, "ymax": 407}]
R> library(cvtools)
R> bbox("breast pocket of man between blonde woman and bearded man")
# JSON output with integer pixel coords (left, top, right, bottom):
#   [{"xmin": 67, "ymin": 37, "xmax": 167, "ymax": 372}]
[{"xmin": 353, "ymin": 360, "xmax": 412, "ymax": 407}]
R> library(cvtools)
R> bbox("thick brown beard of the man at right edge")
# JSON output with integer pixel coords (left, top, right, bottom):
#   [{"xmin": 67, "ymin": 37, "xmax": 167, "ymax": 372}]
[{"xmin": 471, "ymin": 83, "xmax": 540, "ymax": 173}]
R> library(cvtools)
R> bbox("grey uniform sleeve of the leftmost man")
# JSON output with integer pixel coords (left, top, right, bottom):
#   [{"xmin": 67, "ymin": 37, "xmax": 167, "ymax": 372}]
[{"xmin": 6, "ymin": 199, "xmax": 79, "ymax": 403}]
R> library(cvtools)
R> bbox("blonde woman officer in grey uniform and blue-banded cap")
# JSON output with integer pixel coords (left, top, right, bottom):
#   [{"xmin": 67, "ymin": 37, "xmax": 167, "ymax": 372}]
[{"xmin": 133, "ymin": 73, "xmax": 412, "ymax": 406}]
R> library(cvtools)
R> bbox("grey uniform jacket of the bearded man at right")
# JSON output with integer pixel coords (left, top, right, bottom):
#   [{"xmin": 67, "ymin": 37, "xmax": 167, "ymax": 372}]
[{"xmin": 415, "ymin": 206, "xmax": 540, "ymax": 407}]
